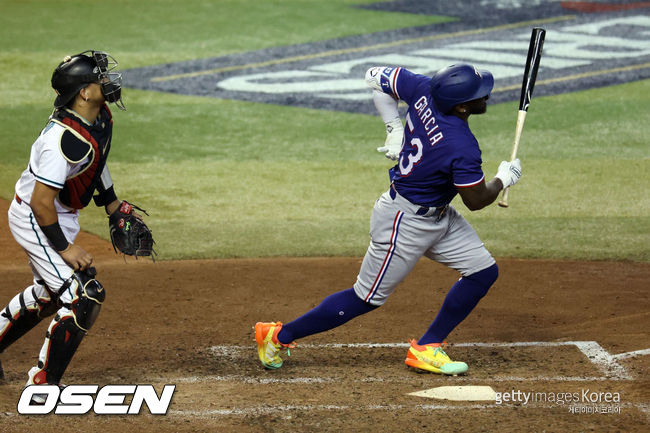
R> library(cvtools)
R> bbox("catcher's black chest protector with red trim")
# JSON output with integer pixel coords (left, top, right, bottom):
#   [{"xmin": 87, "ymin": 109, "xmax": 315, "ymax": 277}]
[{"xmin": 52, "ymin": 105, "xmax": 113, "ymax": 209}]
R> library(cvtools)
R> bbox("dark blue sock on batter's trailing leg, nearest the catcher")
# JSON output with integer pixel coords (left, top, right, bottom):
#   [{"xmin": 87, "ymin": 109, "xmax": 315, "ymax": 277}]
[{"xmin": 278, "ymin": 289, "xmax": 377, "ymax": 344}]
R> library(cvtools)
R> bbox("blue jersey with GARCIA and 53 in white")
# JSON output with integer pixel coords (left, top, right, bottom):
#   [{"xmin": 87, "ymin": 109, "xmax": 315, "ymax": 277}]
[{"xmin": 381, "ymin": 68, "xmax": 485, "ymax": 207}]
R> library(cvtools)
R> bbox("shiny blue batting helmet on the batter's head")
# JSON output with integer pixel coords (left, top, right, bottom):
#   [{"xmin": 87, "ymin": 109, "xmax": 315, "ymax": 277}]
[{"xmin": 431, "ymin": 63, "xmax": 494, "ymax": 113}]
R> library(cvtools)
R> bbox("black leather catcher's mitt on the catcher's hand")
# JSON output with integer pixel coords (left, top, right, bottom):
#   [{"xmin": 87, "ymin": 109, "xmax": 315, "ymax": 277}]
[{"xmin": 108, "ymin": 201, "xmax": 156, "ymax": 259}]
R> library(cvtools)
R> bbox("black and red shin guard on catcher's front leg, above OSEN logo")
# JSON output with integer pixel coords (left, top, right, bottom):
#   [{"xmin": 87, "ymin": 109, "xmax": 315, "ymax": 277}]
[{"xmin": 34, "ymin": 268, "xmax": 106, "ymax": 384}]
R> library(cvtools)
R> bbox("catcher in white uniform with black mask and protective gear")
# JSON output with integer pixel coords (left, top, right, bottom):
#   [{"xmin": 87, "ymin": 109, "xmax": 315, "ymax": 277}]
[{"xmin": 0, "ymin": 51, "xmax": 152, "ymax": 394}]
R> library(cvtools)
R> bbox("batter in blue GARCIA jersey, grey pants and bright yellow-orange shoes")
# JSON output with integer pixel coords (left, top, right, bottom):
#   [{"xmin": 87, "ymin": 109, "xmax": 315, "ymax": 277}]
[{"xmin": 255, "ymin": 63, "xmax": 521, "ymax": 375}]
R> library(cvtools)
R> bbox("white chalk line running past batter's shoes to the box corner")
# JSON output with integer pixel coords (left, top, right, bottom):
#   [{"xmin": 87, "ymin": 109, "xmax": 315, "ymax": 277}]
[{"xmin": 209, "ymin": 341, "xmax": 650, "ymax": 380}]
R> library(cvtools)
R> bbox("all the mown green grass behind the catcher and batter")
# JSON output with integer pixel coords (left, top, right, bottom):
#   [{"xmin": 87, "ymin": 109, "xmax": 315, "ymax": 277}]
[{"xmin": 0, "ymin": 0, "xmax": 650, "ymax": 261}]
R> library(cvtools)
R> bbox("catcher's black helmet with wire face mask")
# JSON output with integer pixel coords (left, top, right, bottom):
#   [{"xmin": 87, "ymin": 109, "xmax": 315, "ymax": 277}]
[{"xmin": 52, "ymin": 51, "xmax": 125, "ymax": 110}]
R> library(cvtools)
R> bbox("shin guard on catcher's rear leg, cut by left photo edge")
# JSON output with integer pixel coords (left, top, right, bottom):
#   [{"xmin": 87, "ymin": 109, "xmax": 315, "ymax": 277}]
[{"xmin": 0, "ymin": 280, "xmax": 58, "ymax": 353}]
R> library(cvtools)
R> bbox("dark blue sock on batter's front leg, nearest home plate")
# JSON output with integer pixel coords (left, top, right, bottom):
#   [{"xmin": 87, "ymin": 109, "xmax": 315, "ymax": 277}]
[{"xmin": 418, "ymin": 263, "xmax": 499, "ymax": 344}]
